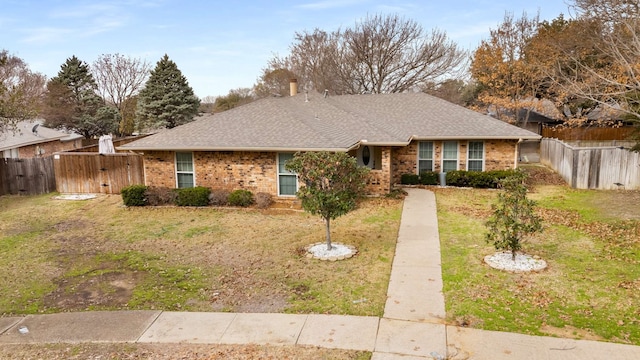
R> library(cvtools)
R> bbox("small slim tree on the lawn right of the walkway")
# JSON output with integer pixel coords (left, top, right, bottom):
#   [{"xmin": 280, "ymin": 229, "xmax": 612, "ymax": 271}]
[{"xmin": 486, "ymin": 171, "xmax": 542, "ymax": 261}]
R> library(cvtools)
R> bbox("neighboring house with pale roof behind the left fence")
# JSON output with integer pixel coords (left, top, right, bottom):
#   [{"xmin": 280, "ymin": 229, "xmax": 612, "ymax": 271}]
[{"xmin": 0, "ymin": 119, "xmax": 84, "ymax": 159}]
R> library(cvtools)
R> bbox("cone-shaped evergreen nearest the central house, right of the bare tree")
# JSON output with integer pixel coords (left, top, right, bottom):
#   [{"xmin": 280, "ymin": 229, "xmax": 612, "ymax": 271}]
[{"xmin": 136, "ymin": 54, "xmax": 200, "ymax": 129}]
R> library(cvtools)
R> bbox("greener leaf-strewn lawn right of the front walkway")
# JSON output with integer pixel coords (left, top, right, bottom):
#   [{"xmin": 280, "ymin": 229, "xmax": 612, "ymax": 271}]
[{"xmin": 437, "ymin": 187, "xmax": 640, "ymax": 345}]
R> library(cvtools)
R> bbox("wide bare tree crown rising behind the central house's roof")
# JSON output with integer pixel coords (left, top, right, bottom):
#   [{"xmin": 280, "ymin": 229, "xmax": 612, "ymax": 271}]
[{"xmin": 265, "ymin": 15, "xmax": 466, "ymax": 94}]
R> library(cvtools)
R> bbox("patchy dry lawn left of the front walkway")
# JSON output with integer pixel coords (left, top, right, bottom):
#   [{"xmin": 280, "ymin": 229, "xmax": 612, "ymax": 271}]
[{"xmin": 0, "ymin": 196, "xmax": 402, "ymax": 316}]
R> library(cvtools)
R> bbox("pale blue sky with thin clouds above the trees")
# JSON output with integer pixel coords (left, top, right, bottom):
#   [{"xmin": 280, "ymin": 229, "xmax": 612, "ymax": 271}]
[{"xmin": 0, "ymin": 0, "xmax": 569, "ymax": 97}]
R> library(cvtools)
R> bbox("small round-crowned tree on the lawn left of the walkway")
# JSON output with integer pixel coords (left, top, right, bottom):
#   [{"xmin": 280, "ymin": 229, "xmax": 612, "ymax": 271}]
[{"xmin": 285, "ymin": 151, "xmax": 369, "ymax": 250}]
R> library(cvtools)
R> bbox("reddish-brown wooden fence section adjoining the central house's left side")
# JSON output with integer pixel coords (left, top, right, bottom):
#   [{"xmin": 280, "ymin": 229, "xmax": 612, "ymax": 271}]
[{"xmin": 53, "ymin": 152, "xmax": 144, "ymax": 194}]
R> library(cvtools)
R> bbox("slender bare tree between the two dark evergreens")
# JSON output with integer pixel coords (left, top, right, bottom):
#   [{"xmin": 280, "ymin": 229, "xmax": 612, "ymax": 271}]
[{"xmin": 92, "ymin": 54, "xmax": 151, "ymax": 135}]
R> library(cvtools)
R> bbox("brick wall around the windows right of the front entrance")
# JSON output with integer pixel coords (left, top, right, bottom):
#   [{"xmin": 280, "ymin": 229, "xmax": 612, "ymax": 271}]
[{"xmin": 391, "ymin": 140, "xmax": 518, "ymax": 184}]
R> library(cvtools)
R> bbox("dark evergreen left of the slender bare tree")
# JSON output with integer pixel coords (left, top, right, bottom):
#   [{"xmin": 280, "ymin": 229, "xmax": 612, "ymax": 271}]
[{"xmin": 43, "ymin": 56, "xmax": 120, "ymax": 138}]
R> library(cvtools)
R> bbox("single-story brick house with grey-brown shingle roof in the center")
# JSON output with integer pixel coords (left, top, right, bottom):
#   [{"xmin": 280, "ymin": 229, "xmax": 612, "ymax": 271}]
[{"xmin": 118, "ymin": 87, "xmax": 540, "ymax": 197}]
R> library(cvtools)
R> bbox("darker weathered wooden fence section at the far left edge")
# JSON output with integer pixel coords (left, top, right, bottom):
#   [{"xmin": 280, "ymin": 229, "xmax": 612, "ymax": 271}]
[{"xmin": 0, "ymin": 157, "xmax": 56, "ymax": 195}]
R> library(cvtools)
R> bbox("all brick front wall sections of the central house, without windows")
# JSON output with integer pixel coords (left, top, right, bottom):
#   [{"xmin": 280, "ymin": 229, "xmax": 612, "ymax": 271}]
[{"xmin": 144, "ymin": 140, "xmax": 517, "ymax": 196}]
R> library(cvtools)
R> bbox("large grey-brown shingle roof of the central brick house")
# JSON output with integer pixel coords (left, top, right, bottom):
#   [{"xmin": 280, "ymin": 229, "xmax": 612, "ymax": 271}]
[{"xmin": 118, "ymin": 93, "xmax": 540, "ymax": 151}]
